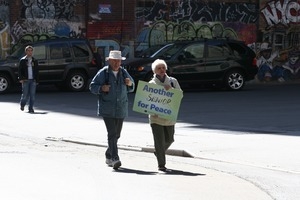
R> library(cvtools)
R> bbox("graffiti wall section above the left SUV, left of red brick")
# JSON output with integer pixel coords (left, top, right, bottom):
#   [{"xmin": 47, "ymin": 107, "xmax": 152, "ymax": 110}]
[{"xmin": 10, "ymin": 0, "xmax": 86, "ymax": 54}]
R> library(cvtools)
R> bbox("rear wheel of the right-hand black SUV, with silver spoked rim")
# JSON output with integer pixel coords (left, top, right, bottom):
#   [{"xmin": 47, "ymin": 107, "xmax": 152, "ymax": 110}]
[{"xmin": 224, "ymin": 70, "xmax": 245, "ymax": 91}]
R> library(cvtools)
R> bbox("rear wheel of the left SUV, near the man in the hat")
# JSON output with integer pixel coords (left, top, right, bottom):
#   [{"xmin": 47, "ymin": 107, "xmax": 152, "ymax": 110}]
[{"xmin": 66, "ymin": 71, "xmax": 88, "ymax": 92}]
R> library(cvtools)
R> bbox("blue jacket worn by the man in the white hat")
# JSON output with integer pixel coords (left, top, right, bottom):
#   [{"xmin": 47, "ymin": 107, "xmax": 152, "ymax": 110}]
[{"xmin": 89, "ymin": 66, "xmax": 135, "ymax": 118}]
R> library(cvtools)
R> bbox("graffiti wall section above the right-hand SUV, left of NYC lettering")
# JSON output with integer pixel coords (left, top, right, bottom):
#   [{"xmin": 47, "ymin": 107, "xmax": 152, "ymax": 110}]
[{"xmin": 135, "ymin": 0, "xmax": 258, "ymax": 51}]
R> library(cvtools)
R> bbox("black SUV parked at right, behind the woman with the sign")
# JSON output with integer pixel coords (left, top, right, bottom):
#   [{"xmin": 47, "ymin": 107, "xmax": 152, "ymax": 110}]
[{"xmin": 123, "ymin": 39, "xmax": 258, "ymax": 90}]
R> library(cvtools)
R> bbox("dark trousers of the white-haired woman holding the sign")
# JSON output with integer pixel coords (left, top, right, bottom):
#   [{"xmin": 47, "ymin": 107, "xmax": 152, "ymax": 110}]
[{"xmin": 151, "ymin": 124, "xmax": 174, "ymax": 167}]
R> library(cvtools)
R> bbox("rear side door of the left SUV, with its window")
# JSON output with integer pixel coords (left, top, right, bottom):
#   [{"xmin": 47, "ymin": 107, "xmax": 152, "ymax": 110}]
[{"xmin": 47, "ymin": 42, "xmax": 73, "ymax": 81}]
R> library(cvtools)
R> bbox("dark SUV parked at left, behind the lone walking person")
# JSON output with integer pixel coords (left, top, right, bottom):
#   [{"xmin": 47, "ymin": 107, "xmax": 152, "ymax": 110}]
[{"xmin": 0, "ymin": 38, "xmax": 98, "ymax": 94}]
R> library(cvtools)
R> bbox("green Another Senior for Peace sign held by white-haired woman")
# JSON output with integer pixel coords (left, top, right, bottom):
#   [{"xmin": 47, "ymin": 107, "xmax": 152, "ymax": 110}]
[{"xmin": 133, "ymin": 81, "xmax": 183, "ymax": 121}]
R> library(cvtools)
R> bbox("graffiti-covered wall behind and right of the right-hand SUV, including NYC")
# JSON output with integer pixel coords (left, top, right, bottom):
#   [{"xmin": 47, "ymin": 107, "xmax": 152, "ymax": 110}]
[{"xmin": 136, "ymin": 0, "xmax": 300, "ymax": 82}]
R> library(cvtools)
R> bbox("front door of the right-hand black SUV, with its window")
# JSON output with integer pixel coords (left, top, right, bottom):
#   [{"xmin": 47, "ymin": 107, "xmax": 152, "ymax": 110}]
[{"xmin": 169, "ymin": 42, "xmax": 205, "ymax": 83}]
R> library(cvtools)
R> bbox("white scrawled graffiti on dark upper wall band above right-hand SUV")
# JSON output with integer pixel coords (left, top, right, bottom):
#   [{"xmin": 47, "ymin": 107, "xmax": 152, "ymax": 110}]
[{"xmin": 136, "ymin": 0, "xmax": 258, "ymax": 23}]
